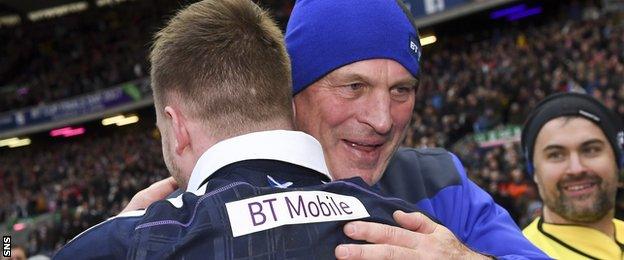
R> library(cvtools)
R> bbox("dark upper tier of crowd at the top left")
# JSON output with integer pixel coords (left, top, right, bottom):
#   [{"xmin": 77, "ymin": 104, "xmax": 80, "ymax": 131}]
[{"xmin": 0, "ymin": 0, "xmax": 294, "ymax": 113}]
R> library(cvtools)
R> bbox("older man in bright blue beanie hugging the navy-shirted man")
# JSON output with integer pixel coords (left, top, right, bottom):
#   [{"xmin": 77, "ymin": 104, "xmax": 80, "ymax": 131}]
[{"xmin": 286, "ymin": 0, "xmax": 545, "ymax": 259}]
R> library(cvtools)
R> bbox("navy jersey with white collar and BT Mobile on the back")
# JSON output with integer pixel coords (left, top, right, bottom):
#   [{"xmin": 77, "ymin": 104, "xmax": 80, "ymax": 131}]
[{"xmin": 55, "ymin": 130, "xmax": 438, "ymax": 259}]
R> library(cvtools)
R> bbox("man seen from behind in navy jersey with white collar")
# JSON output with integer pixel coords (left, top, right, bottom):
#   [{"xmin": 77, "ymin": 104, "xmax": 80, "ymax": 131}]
[{"xmin": 55, "ymin": 0, "xmax": 492, "ymax": 259}]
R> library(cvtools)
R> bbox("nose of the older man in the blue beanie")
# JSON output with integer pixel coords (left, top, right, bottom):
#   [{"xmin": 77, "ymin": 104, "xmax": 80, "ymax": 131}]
[{"xmin": 360, "ymin": 91, "xmax": 392, "ymax": 135}]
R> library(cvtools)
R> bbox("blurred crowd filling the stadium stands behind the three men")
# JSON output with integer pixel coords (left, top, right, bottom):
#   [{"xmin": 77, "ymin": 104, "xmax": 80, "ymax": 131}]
[{"xmin": 0, "ymin": 0, "xmax": 624, "ymax": 253}]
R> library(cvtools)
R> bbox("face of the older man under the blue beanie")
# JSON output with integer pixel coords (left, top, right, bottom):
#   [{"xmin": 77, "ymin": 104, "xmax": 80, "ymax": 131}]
[{"xmin": 294, "ymin": 59, "xmax": 417, "ymax": 185}]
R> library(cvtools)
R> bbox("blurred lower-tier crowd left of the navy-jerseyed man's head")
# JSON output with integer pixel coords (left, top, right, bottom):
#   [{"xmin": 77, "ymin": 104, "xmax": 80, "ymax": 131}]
[{"xmin": 0, "ymin": 124, "xmax": 169, "ymax": 254}]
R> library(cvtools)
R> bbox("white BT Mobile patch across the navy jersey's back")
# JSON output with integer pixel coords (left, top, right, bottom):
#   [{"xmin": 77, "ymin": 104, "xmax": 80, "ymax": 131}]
[{"xmin": 225, "ymin": 191, "xmax": 370, "ymax": 237}]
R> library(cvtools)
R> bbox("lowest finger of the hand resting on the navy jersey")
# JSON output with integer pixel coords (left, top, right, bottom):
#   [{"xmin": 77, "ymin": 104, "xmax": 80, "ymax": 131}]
[{"xmin": 334, "ymin": 244, "xmax": 418, "ymax": 260}]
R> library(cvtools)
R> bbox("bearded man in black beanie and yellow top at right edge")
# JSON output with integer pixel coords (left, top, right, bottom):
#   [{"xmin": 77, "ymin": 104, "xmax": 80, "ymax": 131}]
[{"xmin": 522, "ymin": 93, "xmax": 624, "ymax": 259}]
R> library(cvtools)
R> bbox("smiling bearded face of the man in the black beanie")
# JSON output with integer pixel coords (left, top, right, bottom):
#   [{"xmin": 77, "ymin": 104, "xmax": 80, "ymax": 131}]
[{"xmin": 533, "ymin": 117, "xmax": 618, "ymax": 223}]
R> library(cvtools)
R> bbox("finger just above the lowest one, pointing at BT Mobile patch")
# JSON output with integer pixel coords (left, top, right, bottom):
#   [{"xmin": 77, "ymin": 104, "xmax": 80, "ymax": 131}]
[{"xmin": 343, "ymin": 221, "xmax": 423, "ymax": 248}]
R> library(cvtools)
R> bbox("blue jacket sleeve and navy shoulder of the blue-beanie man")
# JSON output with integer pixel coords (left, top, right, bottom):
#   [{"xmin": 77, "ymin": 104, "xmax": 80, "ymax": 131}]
[{"xmin": 380, "ymin": 149, "xmax": 549, "ymax": 259}]
